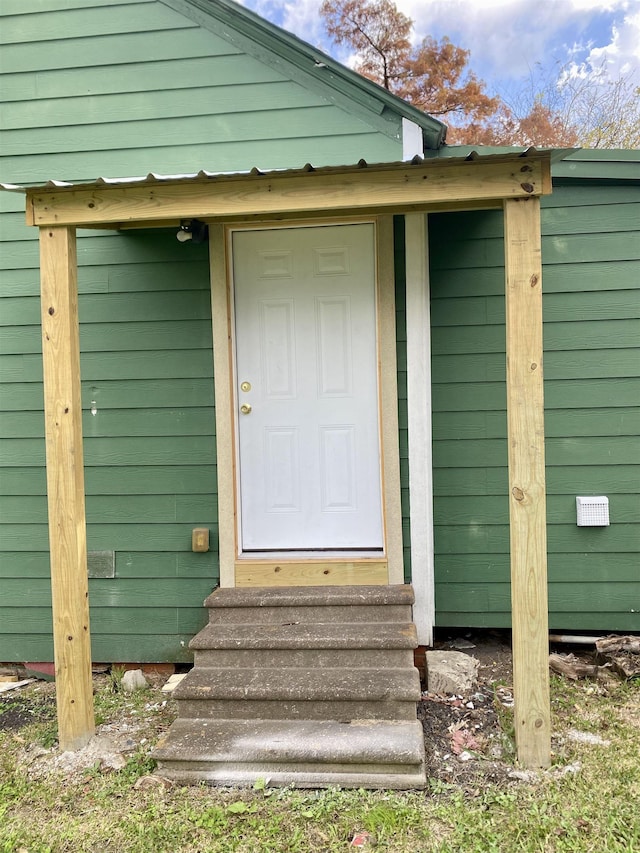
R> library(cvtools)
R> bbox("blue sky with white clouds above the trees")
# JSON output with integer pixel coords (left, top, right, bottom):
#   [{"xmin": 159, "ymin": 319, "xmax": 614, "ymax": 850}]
[{"xmin": 239, "ymin": 0, "xmax": 640, "ymax": 96}]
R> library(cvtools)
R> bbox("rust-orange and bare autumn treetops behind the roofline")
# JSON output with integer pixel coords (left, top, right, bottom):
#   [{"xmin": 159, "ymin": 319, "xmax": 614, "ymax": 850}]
[{"xmin": 320, "ymin": 0, "xmax": 640, "ymax": 148}]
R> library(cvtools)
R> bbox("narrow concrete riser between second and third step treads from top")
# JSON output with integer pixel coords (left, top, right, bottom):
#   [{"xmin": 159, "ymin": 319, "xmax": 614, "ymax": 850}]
[{"xmin": 194, "ymin": 648, "xmax": 413, "ymax": 672}]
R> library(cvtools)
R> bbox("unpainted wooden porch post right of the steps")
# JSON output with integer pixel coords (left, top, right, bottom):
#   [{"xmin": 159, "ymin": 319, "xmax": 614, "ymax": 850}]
[{"xmin": 504, "ymin": 198, "xmax": 551, "ymax": 767}]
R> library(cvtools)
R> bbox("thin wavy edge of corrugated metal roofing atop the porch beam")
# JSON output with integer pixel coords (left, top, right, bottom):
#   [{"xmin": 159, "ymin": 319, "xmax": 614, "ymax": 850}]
[{"xmin": 0, "ymin": 148, "xmax": 556, "ymax": 192}]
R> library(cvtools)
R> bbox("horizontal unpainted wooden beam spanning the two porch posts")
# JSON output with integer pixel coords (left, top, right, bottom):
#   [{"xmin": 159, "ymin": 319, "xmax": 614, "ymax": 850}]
[{"xmin": 27, "ymin": 152, "xmax": 551, "ymax": 228}]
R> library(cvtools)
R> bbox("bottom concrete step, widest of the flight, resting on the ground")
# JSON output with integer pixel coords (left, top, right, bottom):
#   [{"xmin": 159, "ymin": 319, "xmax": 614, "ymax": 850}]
[{"xmin": 154, "ymin": 719, "xmax": 425, "ymax": 788}]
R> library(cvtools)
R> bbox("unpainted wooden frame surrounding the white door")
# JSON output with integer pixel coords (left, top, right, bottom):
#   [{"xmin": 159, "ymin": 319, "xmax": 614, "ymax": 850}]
[{"xmin": 209, "ymin": 216, "xmax": 404, "ymax": 587}]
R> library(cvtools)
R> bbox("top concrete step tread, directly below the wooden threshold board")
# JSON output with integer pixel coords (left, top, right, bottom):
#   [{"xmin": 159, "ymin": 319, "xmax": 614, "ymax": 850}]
[{"xmin": 204, "ymin": 584, "xmax": 415, "ymax": 608}]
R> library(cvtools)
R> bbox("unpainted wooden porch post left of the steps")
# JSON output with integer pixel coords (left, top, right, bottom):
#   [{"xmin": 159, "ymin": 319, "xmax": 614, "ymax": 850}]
[{"xmin": 40, "ymin": 226, "xmax": 95, "ymax": 750}]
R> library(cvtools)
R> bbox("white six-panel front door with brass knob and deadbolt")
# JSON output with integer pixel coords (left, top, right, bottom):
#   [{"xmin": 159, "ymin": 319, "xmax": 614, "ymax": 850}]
[{"xmin": 233, "ymin": 223, "xmax": 383, "ymax": 552}]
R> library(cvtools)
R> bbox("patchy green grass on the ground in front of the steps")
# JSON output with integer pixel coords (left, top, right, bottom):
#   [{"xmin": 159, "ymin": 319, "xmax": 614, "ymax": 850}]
[{"xmin": 0, "ymin": 677, "xmax": 640, "ymax": 853}]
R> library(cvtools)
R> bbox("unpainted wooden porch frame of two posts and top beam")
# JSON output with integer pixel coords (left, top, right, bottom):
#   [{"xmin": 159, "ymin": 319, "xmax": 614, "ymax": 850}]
[{"xmin": 26, "ymin": 151, "xmax": 551, "ymax": 767}]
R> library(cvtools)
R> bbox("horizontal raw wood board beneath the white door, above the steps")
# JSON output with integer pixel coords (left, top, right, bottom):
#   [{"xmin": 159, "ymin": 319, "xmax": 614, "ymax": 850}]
[{"xmin": 235, "ymin": 558, "xmax": 389, "ymax": 587}]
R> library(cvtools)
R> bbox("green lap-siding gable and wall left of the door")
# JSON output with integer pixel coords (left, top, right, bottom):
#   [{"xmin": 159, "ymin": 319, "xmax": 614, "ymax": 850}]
[{"xmin": 0, "ymin": 0, "xmax": 402, "ymax": 661}]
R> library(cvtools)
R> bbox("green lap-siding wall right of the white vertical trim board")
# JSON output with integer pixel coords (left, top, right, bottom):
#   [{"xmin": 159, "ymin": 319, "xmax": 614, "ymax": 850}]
[{"xmin": 430, "ymin": 168, "xmax": 640, "ymax": 631}]
